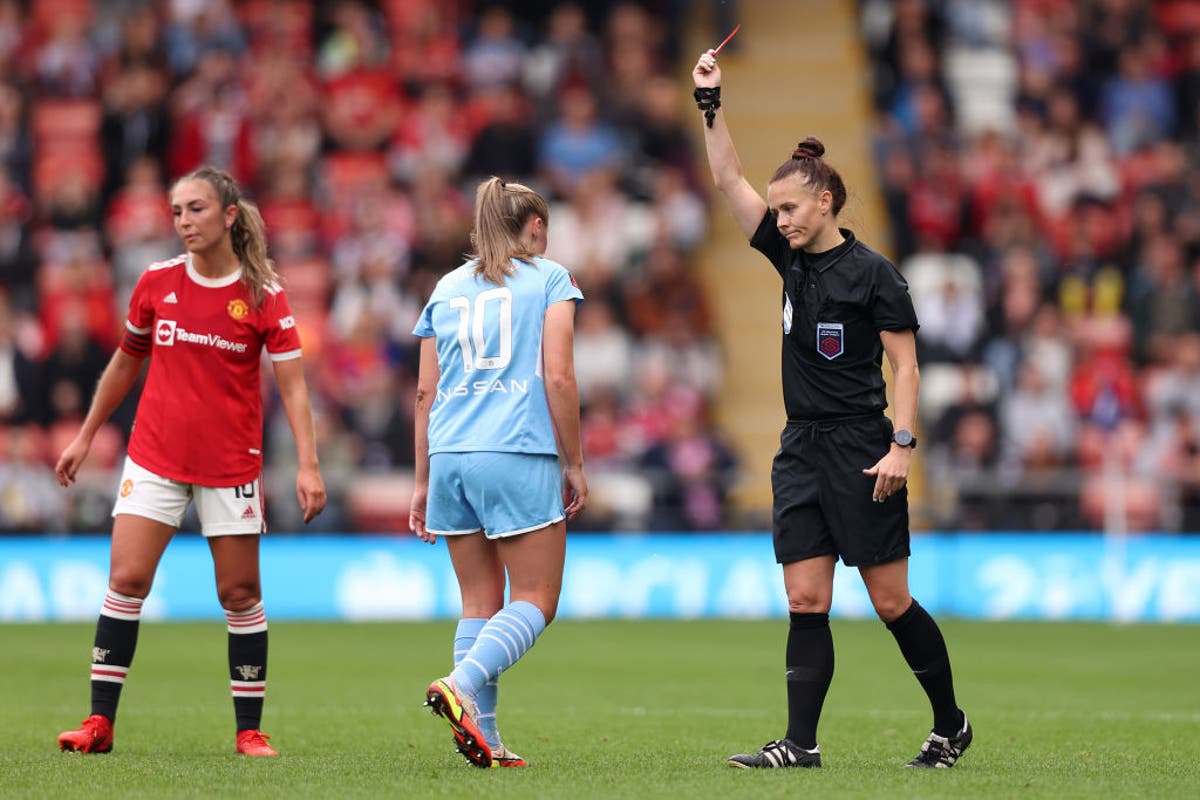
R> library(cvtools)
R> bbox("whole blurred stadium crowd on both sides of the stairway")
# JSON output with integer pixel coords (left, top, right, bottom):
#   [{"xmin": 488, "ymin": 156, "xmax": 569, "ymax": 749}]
[{"xmin": 9, "ymin": 0, "xmax": 1200, "ymax": 531}]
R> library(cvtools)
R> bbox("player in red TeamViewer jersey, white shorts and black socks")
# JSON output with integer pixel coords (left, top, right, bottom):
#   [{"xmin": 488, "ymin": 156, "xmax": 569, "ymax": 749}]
[{"xmin": 55, "ymin": 168, "xmax": 325, "ymax": 756}]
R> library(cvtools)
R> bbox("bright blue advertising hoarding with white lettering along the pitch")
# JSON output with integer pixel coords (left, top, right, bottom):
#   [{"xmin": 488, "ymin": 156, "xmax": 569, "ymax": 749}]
[{"xmin": 0, "ymin": 534, "xmax": 1200, "ymax": 622}]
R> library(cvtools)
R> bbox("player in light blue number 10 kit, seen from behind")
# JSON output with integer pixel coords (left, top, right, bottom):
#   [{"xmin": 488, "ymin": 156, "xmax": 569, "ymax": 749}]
[{"xmin": 409, "ymin": 178, "xmax": 588, "ymax": 766}]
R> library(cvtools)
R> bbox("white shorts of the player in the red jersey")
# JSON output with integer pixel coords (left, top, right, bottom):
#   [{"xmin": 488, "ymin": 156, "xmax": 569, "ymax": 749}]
[{"xmin": 113, "ymin": 456, "xmax": 266, "ymax": 536}]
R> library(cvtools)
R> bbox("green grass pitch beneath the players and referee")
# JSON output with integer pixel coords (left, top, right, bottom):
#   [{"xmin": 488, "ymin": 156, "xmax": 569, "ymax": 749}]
[{"xmin": 0, "ymin": 620, "xmax": 1200, "ymax": 800}]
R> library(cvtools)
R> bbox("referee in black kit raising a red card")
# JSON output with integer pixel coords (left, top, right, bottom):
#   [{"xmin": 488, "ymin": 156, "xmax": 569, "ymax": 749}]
[{"xmin": 692, "ymin": 50, "xmax": 972, "ymax": 768}]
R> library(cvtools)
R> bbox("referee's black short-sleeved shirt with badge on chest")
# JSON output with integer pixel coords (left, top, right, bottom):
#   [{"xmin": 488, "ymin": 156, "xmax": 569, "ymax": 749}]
[{"xmin": 750, "ymin": 211, "xmax": 917, "ymax": 420}]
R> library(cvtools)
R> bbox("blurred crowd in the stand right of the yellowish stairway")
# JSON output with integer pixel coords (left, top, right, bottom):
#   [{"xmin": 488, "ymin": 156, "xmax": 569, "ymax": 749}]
[{"xmin": 860, "ymin": 0, "xmax": 1200, "ymax": 531}]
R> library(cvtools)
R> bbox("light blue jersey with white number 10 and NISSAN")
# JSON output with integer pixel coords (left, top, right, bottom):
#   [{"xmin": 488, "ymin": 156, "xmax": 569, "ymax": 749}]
[{"xmin": 413, "ymin": 258, "xmax": 583, "ymax": 456}]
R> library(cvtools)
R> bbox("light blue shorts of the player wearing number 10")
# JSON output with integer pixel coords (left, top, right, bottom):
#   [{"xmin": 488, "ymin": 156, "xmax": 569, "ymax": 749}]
[{"xmin": 425, "ymin": 452, "xmax": 566, "ymax": 539}]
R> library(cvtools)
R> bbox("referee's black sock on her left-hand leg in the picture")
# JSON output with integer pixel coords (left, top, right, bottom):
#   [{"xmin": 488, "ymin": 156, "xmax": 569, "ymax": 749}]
[{"xmin": 787, "ymin": 613, "xmax": 833, "ymax": 750}]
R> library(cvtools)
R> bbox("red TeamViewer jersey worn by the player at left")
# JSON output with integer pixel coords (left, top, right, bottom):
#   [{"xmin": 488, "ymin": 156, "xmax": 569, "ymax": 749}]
[{"xmin": 121, "ymin": 255, "xmax": 300, "ymax": 486}]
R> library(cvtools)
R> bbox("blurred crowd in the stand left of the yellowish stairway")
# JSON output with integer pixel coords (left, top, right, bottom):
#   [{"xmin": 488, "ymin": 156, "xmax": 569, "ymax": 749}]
[{"xmin": 0, "ymin": 0, "xmax": 736, "ymax": 531}]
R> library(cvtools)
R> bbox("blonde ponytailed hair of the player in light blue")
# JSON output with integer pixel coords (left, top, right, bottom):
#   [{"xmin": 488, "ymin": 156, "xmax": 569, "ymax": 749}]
[{"xmin": 470, "ymin": 178, "xmax": 550, "ymax": 284}]
